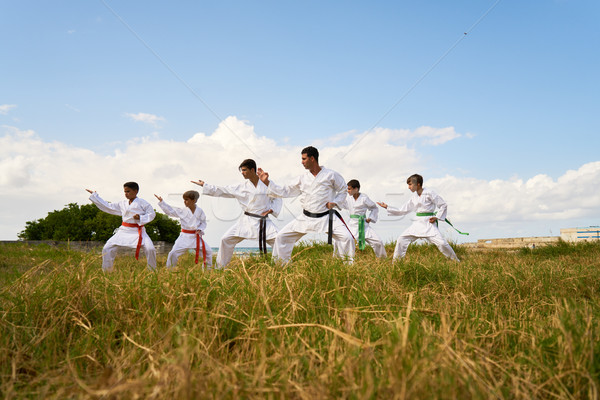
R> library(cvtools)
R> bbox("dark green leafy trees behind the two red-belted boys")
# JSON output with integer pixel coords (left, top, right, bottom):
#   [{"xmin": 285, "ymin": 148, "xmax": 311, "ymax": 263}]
[{"xmin": 18, "ymin": 203, "xmax": 181, "ymax": 243}]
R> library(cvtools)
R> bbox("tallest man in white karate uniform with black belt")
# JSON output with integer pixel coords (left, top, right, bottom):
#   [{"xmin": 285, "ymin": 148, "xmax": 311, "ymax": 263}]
[{"xmin": 258, "ymin": 146, "xmax": 354, "ymax": 263}]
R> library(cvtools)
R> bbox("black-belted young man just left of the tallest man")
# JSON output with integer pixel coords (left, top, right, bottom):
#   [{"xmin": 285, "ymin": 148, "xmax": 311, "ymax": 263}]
[{"xmin": 192, "ymin": 159, "xmax": 283, "ymax": 268}]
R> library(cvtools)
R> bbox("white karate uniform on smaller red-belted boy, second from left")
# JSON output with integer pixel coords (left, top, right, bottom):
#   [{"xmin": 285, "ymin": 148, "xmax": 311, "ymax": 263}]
[{"xmin": 158, "ymin": 201, "xmax": 212, "ymax": 268}]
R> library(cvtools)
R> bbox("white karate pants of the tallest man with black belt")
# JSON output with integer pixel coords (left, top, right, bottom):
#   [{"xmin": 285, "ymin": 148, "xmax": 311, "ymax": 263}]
[{"xmin": 273, "ymin": 217, "xmax": 355, "ymax": 263}]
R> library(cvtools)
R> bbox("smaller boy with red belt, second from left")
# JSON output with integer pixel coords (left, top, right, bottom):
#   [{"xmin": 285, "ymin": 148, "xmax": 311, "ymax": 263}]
[{"xmin": 154, "ymin": 190, "xmax": 212, "ymax": 269}]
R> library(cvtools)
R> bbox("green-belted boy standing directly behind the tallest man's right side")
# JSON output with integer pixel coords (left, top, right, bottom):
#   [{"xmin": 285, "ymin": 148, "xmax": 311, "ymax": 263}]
[{"xmin": 342, "ymin": 179, "xmax": 387, "ymax": 258}]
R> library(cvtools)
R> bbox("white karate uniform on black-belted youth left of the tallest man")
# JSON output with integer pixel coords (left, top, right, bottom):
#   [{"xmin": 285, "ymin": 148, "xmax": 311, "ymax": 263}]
[{"xmin": 202, "ymin": 179, "xmax": 283, "ymax": 268}]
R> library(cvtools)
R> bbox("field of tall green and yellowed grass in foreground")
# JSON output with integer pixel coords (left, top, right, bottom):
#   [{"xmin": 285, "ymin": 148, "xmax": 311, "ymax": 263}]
[{"xmin": 0, "ymin": 242, "xmax": 600, "ymax": 400}]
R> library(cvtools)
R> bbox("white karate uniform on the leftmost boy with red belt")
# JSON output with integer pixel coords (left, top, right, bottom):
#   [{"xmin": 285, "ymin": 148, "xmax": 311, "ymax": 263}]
[{"xmin": 90, "ymin": 192, "xmax": 156, "ymax": 272}]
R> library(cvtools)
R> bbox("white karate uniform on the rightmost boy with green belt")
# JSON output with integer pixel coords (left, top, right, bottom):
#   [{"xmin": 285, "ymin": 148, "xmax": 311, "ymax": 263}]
[{"xmin": 388, "ymin": 188, "xmax": 459, "ymax": 261}]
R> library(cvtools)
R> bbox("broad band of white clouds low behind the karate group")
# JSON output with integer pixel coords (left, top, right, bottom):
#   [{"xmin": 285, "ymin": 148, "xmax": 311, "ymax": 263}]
[{"xmin": 0, "ymin": 117, "xmax": 600, "ymax": 246}]
